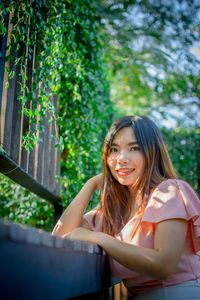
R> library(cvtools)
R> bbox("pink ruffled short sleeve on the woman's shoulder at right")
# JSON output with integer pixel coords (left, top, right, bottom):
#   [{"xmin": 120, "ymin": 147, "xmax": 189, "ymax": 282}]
[{"xmin": 142, "ymin": 179, "xmax": 200, "ymax": 254}]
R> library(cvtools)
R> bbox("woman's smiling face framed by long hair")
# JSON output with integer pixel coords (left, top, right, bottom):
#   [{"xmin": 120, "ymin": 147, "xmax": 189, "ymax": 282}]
[{"xmin": 107, "ymin": 127, "xmax": 144, "ymax": 189}]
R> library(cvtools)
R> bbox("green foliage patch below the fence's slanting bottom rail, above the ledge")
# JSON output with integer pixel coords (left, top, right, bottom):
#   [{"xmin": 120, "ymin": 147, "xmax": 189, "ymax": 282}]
[{"xmin": 0, "ymin": 175, "xmax": 53, "ymax": 230}]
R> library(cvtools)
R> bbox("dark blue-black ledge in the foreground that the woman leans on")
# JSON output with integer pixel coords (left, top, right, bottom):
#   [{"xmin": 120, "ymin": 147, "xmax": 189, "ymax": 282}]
[{"xmin": 0, "ymin": 221, "xmax": 119, "ymax": 300}]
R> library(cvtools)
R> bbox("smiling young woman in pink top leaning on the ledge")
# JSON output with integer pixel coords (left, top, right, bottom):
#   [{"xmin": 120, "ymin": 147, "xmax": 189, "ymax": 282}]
[{"xmin": 53, "ymin": 116, "xmax": 200, "ymax": 300}]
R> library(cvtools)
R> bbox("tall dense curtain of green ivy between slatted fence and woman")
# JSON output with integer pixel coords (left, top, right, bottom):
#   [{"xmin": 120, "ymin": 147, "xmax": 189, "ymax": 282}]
[{"xmin": 54, "ymin": 1, "xmax": 113, "ymax": 206}]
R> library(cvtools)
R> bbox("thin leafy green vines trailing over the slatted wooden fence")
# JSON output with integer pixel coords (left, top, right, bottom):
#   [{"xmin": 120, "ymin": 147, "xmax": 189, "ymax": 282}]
[{"xmin": 1, "ymin": 0, "xmax": 62, "ymax": 150}]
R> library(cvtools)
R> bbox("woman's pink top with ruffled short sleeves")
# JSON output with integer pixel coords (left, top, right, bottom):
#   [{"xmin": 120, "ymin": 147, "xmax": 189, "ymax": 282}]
[{"xmin": 85, "ymin": 179, "xmax": 200, "ymax": 290}]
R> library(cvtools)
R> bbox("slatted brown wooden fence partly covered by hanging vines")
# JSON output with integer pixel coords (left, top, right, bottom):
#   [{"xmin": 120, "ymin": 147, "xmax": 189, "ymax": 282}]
[{"xmin": 0, "ymin": 7, "xmax": 60, "ymax": 211}]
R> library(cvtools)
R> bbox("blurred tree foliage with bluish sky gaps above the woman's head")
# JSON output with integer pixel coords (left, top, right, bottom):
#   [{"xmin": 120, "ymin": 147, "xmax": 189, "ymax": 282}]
[{"xmin": 96, "ymin": 0, "xmax": 200, "ymax": 124}]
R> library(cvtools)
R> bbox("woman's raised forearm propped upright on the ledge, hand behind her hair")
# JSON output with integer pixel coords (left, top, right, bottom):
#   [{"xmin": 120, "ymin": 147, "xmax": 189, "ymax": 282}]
[{"xmin": 52, "ymin": 174, "xmax": 102, "ymax": 236}]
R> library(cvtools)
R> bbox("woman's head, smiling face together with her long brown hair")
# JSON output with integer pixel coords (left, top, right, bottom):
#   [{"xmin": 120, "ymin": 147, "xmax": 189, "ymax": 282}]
[{"xmin": 94, "ymin": 116, "xmax": 176, "ymax": 235}]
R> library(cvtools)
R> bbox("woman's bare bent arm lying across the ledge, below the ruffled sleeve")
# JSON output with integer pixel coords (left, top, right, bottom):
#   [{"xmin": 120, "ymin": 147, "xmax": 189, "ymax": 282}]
[{"xmin": 67, "ymin": 219, "xmax": 187, "ymax": 279}]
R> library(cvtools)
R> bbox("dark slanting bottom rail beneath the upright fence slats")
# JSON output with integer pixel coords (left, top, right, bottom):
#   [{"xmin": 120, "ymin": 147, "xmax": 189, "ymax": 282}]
[{"xmin": 0, "ymin": 152, "xmax": 60, "ymax": 204}]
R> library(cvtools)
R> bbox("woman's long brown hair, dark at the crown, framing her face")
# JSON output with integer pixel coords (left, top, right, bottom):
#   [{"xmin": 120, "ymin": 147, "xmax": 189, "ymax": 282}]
[{"xmin": 93, "ymin": 116, "xmax": 176, "ymax": 236}]
